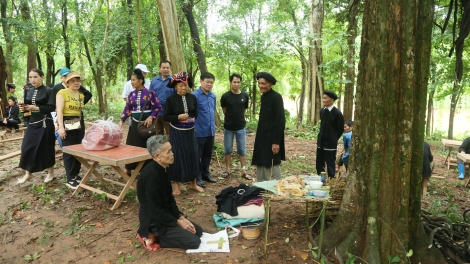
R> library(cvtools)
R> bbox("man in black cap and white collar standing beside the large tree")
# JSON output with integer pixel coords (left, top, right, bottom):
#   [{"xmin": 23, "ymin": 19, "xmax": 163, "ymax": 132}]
[{"xmin": 316, "ymin": 90, "xmax": 344, "ymax": 178}]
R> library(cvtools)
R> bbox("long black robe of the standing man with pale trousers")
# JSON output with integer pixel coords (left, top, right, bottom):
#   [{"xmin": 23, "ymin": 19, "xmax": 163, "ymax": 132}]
[{"xmin": 251, "ymin": 89, "xmax": 286, "ymax": 168}]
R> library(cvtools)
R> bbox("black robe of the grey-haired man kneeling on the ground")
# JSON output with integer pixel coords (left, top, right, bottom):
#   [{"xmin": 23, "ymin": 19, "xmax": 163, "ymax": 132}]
[{"xmin": 137, "ymin": 160, "xmax": 183, "ymax": 237}]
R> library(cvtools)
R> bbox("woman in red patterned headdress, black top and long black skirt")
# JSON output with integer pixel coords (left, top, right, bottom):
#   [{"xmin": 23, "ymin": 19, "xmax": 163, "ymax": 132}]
[{"xmin": 163, "ymin": 72, "xmax": 204, "ymax": 196}]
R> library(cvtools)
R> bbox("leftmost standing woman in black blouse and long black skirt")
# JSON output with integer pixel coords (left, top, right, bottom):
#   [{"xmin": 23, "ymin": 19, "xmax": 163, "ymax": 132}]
[{"xmin": 18, "ymin": 69, "xmax": 55, "ymax": 184}]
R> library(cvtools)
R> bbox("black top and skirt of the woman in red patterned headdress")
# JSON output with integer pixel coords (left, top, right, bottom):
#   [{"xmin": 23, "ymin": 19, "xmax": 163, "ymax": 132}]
[{"xmin": 163, "ymin": 94, "xmax": 199, "ymax": 182}]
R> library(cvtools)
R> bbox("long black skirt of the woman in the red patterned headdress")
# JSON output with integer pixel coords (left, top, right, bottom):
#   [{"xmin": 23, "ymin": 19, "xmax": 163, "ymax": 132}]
[{"xmin": 170, "ymin": 126, "xmax": 199, "ymax": 182}]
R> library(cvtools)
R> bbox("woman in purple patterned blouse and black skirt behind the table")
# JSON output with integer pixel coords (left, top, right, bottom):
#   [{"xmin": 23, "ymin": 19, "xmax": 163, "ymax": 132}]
[{"xmin": 119, "ymin": 69, "xmax": 162, "ymax": 175}]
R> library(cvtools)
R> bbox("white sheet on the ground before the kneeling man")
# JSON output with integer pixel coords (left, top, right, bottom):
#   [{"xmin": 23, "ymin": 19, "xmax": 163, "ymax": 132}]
[{"xmin": 186, "ymin": 225, "xmax": 240, "ymax": 253}]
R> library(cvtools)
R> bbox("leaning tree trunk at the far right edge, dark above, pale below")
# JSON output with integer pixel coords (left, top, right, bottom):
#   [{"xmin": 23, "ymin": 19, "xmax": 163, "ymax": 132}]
[{"xmin": 447, "ymin": 1, "xmax": 470, "ymax": 139}]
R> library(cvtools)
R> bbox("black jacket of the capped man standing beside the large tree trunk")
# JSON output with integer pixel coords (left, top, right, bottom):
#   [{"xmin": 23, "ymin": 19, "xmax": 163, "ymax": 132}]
[{"xmin": 317, "ymin": 106, "xmax": 344, "ymax": 149}]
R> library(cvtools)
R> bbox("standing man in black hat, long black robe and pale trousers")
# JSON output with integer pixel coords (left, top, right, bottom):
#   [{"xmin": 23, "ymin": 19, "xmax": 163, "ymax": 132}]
[{"xmin": 251, "ymin": 72, "xmax": 286, "ymax": 182}]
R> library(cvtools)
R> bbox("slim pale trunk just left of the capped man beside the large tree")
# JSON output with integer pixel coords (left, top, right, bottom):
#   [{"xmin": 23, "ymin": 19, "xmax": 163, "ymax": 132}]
[{"xmin": 308, "ymin": 0, "xmax": 324, "ymax": 125}]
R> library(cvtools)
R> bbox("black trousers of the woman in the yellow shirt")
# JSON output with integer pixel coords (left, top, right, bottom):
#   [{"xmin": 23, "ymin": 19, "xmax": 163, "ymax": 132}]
[{"xmin": 62, "ymin": 126, "xmax": 85, "ymax": 182}]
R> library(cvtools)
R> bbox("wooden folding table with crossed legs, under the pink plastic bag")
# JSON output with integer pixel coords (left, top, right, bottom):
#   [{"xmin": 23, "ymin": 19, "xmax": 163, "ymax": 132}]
[{"xmin": 62, "ymin": 144, "xmax": 152, "ymax": 210}]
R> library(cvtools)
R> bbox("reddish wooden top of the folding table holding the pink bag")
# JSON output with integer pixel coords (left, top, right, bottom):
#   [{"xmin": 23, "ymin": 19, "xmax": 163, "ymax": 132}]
[{"xmin": 62, "ymin": 144, "xmax": 152, "ymax": 166}]
